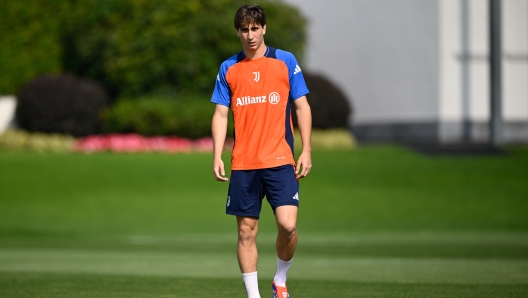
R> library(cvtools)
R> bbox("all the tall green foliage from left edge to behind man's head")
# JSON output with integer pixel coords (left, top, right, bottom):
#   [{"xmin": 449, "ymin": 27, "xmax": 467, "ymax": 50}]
[{"xmin": 0, "ymin": 0, "xmax": 306, "ymax": 97}]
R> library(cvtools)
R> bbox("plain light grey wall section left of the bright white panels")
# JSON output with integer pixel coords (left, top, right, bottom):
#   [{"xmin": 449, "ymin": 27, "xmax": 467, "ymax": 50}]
[{"xmin": 282, "ymin": 0, "xmax": 438, "ymax": 124}]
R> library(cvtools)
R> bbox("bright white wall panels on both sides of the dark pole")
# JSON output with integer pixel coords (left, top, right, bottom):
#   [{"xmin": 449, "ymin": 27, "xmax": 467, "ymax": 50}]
[{"xmin": 438, "ymin": 0, "xmax": 528, "ymax": 142}]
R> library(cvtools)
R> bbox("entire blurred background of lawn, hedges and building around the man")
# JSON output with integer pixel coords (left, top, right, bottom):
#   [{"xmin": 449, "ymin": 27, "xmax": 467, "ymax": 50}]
[{"xmin": 0, "ymin": 0, "xmax": 528, "ymax": 298}]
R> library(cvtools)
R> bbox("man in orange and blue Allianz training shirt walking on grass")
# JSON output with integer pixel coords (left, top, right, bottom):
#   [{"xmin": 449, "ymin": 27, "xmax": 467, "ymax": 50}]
[{"xmin": 211, "ymin": 5, "xmax": 312, "ymax": 298}]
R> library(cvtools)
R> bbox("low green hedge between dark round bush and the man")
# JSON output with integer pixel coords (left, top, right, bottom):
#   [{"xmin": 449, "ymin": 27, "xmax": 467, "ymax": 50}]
[{"xmin": 101, "ymin": 97, "xmax": 232, "ymax": 139}]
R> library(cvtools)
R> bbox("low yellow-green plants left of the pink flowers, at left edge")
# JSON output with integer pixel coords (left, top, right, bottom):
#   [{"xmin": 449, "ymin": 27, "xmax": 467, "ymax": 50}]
[{"xmin": 0, "ymin": 129, "xmax": 75, "ymax": 153}]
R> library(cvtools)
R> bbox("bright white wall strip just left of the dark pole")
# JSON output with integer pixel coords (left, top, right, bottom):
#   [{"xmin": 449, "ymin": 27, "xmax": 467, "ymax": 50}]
[{"xmin": 438, "ymin": 0, "xmax": 490, "ymax": 142}]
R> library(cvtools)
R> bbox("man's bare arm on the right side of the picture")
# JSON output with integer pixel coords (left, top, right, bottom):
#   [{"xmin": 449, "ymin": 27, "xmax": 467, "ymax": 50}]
[{"xmin": 293, "ymin": 96, "xmax": 312, "ymax": 178}]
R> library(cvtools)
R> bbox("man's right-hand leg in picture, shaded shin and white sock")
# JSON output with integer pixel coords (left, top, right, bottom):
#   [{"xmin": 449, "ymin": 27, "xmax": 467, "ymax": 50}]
[{"xmin": 273, "ymin": 206, "xmax": 298, "ymax": 287}]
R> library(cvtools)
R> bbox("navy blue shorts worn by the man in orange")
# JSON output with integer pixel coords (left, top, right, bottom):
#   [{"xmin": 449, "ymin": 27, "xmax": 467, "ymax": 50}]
[{"xmin": 226, "ymin": 165, "xmax": 299, "ymax": 218}]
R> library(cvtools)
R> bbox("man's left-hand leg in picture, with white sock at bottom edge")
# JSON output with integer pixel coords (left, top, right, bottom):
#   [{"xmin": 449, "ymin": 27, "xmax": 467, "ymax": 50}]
[{"xmin": 237, "ymin": 216, "xmax": 260, "ymax": 298}]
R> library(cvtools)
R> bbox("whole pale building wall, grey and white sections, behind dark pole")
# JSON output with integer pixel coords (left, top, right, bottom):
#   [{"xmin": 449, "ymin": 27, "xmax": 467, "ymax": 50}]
[{"xmin": 284, "ymin": 0, "xmax": 528, "ymax": 142}]
